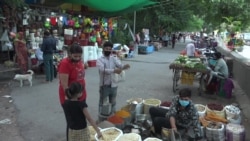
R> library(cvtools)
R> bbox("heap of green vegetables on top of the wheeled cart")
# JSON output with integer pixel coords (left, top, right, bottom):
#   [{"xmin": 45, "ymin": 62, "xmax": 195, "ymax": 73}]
[{"xmin": 169, "ymin": 55, "xmax": 207, "ymax": 72}]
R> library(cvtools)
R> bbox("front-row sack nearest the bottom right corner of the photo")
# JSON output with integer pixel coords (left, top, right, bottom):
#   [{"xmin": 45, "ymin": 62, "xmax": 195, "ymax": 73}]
[{"xmin": 226, "ymin": 123, "xmax": 246, "ymax": 141}]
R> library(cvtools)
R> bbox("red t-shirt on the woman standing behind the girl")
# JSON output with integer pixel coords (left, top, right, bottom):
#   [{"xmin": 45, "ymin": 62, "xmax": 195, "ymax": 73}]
[{"xmin": 58, "ymin": 58, "xmax": 87, "ymax": 104}]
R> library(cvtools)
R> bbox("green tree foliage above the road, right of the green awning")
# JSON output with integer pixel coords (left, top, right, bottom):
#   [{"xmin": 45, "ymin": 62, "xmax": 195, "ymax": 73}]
[{"xmin": 116, "ymin": 0, "xmax": 250, "ymax": 39}]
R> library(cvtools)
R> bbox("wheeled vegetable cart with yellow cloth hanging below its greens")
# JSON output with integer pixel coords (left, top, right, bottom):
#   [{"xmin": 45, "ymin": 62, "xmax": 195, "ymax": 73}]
[{"xmin": 169, "ymin": 55, "xmax": 208, "ymax": 95}]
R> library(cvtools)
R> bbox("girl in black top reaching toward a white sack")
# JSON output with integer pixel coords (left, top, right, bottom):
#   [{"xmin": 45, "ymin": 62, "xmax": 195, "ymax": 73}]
[{"xmin": 62, "ymin": 82, "xmax": 102, "ymax": 141}]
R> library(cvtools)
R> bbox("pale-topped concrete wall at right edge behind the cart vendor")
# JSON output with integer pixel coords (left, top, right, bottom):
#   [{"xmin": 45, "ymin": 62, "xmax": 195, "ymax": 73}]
[{"xmin": 218, "ymin": 40, "xmax": 250, "ymax": 96}]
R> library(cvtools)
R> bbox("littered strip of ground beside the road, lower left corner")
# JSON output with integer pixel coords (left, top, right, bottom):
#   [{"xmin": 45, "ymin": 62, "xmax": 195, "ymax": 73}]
[{"xmin": 0, "ymin": 74, "xmax": 24, "ymax": 141}]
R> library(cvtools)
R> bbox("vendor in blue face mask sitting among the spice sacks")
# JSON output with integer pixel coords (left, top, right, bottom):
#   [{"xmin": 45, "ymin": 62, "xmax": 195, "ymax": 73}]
[{"xmin": 149, "ymin": 88, "xmax": 201, "ymax": 140}]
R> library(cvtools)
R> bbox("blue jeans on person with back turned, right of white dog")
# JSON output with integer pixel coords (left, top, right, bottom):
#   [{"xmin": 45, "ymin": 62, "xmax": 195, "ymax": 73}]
[{"xmin": 43, "ymin": 54, "xmax": 54, "ymax": 81}]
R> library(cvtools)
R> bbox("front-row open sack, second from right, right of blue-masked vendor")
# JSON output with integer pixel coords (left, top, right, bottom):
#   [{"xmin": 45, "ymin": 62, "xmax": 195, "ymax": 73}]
[{"xmin": 206, "ymin": 122, "xmax": 225, "ymax": 141}]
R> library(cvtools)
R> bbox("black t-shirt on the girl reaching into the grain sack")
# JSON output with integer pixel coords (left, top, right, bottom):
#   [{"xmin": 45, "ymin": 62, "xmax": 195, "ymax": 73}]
[{"xmin": 62, "ymin": 100, "xmax": 88, "ymax": 130}]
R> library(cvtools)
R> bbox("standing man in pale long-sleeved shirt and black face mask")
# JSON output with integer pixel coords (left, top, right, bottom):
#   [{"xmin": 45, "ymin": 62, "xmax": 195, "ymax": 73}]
[{"xmin": 97, "ymin": 41, "xmax": 130, "ymax": 116}]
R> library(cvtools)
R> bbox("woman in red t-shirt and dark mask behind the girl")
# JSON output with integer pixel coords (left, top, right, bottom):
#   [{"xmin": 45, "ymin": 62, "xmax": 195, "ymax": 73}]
[{"xmin": 58, "ymin": 44, "xmax": 87, "ymax": 105}]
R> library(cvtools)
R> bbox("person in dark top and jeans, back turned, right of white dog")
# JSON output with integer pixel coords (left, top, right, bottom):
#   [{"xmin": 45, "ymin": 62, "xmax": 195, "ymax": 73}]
[{"xmin": 41, "ymin": 31, "xmax": 56, "ymax": 82}]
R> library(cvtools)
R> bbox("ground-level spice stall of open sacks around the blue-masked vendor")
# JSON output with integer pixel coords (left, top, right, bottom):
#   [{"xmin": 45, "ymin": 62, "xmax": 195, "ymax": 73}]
[{"xmin": 91, "ymin": 98, "xmax": 246, "ymax": 141}]
